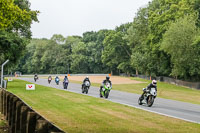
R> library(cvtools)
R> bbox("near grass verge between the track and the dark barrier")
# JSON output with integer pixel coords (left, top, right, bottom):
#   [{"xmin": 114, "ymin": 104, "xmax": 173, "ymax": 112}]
[{"xmin": 8, "ymin": 79, "xmax": 200, "ymax": 133}]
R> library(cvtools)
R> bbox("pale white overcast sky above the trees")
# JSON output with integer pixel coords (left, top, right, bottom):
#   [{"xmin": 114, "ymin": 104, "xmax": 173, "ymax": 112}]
[{"xmin": 29, "ymin": 0, "xmax": 151, "ymax": 38}]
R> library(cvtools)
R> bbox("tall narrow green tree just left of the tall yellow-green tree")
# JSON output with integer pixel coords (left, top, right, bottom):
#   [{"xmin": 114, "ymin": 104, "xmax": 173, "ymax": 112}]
[{"xmin": 124, "ymin": 7, "xmax": 149, "ymax": 74}]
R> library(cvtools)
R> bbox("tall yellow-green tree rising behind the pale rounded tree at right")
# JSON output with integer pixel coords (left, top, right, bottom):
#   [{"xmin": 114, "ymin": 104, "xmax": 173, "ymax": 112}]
[{"xmin": 144, "ymin": 0, "xmax": 196, "ymax": 75}]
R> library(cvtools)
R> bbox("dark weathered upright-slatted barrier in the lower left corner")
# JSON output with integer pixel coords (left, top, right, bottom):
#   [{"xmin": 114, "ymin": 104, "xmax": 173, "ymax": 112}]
[{"xmin": 0, "ymin": 89, "xmax": 64, "ymax": 133}]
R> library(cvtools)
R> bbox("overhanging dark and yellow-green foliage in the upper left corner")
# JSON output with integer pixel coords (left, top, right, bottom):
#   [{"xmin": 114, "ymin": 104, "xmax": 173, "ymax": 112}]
[{"xmin": 0, "ymin": 0, "xmax": 39, "ymax": 65}]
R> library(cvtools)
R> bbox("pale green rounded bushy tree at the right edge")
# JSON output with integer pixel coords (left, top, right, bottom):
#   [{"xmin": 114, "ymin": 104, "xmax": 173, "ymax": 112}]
[{"xmin": 161, "ymin": 15, "xmax": 200, "ymax": 79}]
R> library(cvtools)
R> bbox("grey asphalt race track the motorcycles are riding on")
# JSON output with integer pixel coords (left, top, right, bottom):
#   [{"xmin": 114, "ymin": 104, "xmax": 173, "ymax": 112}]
[{"xmin": 18, "ymin": 78, "xmax": 200, "ymax": 124}]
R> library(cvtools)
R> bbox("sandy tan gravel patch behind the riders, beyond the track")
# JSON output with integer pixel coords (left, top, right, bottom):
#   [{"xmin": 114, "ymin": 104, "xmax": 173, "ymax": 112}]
[{"xmin": 68, "ymin": 76, "xmax": 144, "ymax": 84}]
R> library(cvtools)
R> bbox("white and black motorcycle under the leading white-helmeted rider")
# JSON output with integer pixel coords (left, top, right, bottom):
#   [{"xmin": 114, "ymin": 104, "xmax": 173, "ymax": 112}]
[{"xmin": 138, "ymin": 88, "xmax": 157, "ymax": 107}]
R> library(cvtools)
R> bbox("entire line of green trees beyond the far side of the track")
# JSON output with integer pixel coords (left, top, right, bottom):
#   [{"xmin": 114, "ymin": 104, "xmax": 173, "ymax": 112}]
[{"xmin": 1, "ymin": 0, "xmax": 200, "ymax": 81}]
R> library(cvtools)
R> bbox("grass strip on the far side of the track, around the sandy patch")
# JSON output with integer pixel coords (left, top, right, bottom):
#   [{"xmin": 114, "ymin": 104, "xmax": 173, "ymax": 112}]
[{"xmin": 70, "ymin": 77, "xmax": 200, "ymax": 104}]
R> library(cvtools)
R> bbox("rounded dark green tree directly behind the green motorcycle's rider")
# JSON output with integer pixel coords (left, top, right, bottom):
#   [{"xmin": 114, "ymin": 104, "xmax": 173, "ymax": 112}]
[{"xmin": 102, "ymin": 31, "xmax": 130, "ymax": 72}]
